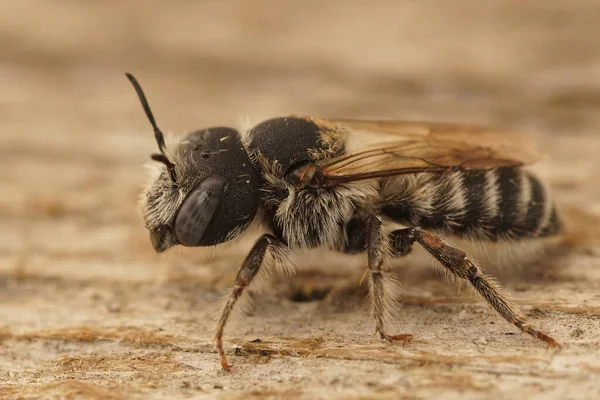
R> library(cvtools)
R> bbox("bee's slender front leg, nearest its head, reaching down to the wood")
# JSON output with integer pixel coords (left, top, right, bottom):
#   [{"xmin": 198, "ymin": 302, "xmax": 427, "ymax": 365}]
[{"xmin": 215, "ymin": 235, "xmax": 286, "ymax": 371}]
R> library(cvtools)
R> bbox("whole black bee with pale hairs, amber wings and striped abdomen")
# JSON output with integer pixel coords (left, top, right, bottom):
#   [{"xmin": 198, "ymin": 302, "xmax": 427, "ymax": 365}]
[{"xmin": 127, "ymin": 74, "xmax": 563, "ymax": 370}]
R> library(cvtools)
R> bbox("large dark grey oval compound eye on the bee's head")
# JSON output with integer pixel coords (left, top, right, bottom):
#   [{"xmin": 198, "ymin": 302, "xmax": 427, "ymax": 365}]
[{"xmin": 175, "ymin": 175, "xmax": 227, "ymax": 246}]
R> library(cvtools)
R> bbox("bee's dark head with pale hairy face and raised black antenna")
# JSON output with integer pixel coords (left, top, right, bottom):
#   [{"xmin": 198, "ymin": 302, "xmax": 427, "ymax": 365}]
[{"xmin": 127, "ymin": 74, "xmax": 259, "ymax": 252}]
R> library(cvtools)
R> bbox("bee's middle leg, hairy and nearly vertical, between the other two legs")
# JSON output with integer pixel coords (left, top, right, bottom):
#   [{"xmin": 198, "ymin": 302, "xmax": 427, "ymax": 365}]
[{"xmin": 366, "ymin": 216, "xmax": 412, "ymax": 342}]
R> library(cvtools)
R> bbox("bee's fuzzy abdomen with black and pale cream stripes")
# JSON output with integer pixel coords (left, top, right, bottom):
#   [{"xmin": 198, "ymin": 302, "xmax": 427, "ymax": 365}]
[{"xmin": 381, "ymin": 167, "xmax": 561, "ymax": 241}]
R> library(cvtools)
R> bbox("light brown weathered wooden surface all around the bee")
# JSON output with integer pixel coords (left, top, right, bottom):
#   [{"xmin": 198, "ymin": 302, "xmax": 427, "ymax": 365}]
[{"xmin": 0, "ymin": 0, "xmax": 600, "ymax": 399}]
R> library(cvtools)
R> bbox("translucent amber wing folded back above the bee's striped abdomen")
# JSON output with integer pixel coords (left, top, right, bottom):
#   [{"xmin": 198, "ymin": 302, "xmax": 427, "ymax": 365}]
[{"xmin": 317, "ymin": 120, "xmax": 541, "ymax": 185}]
